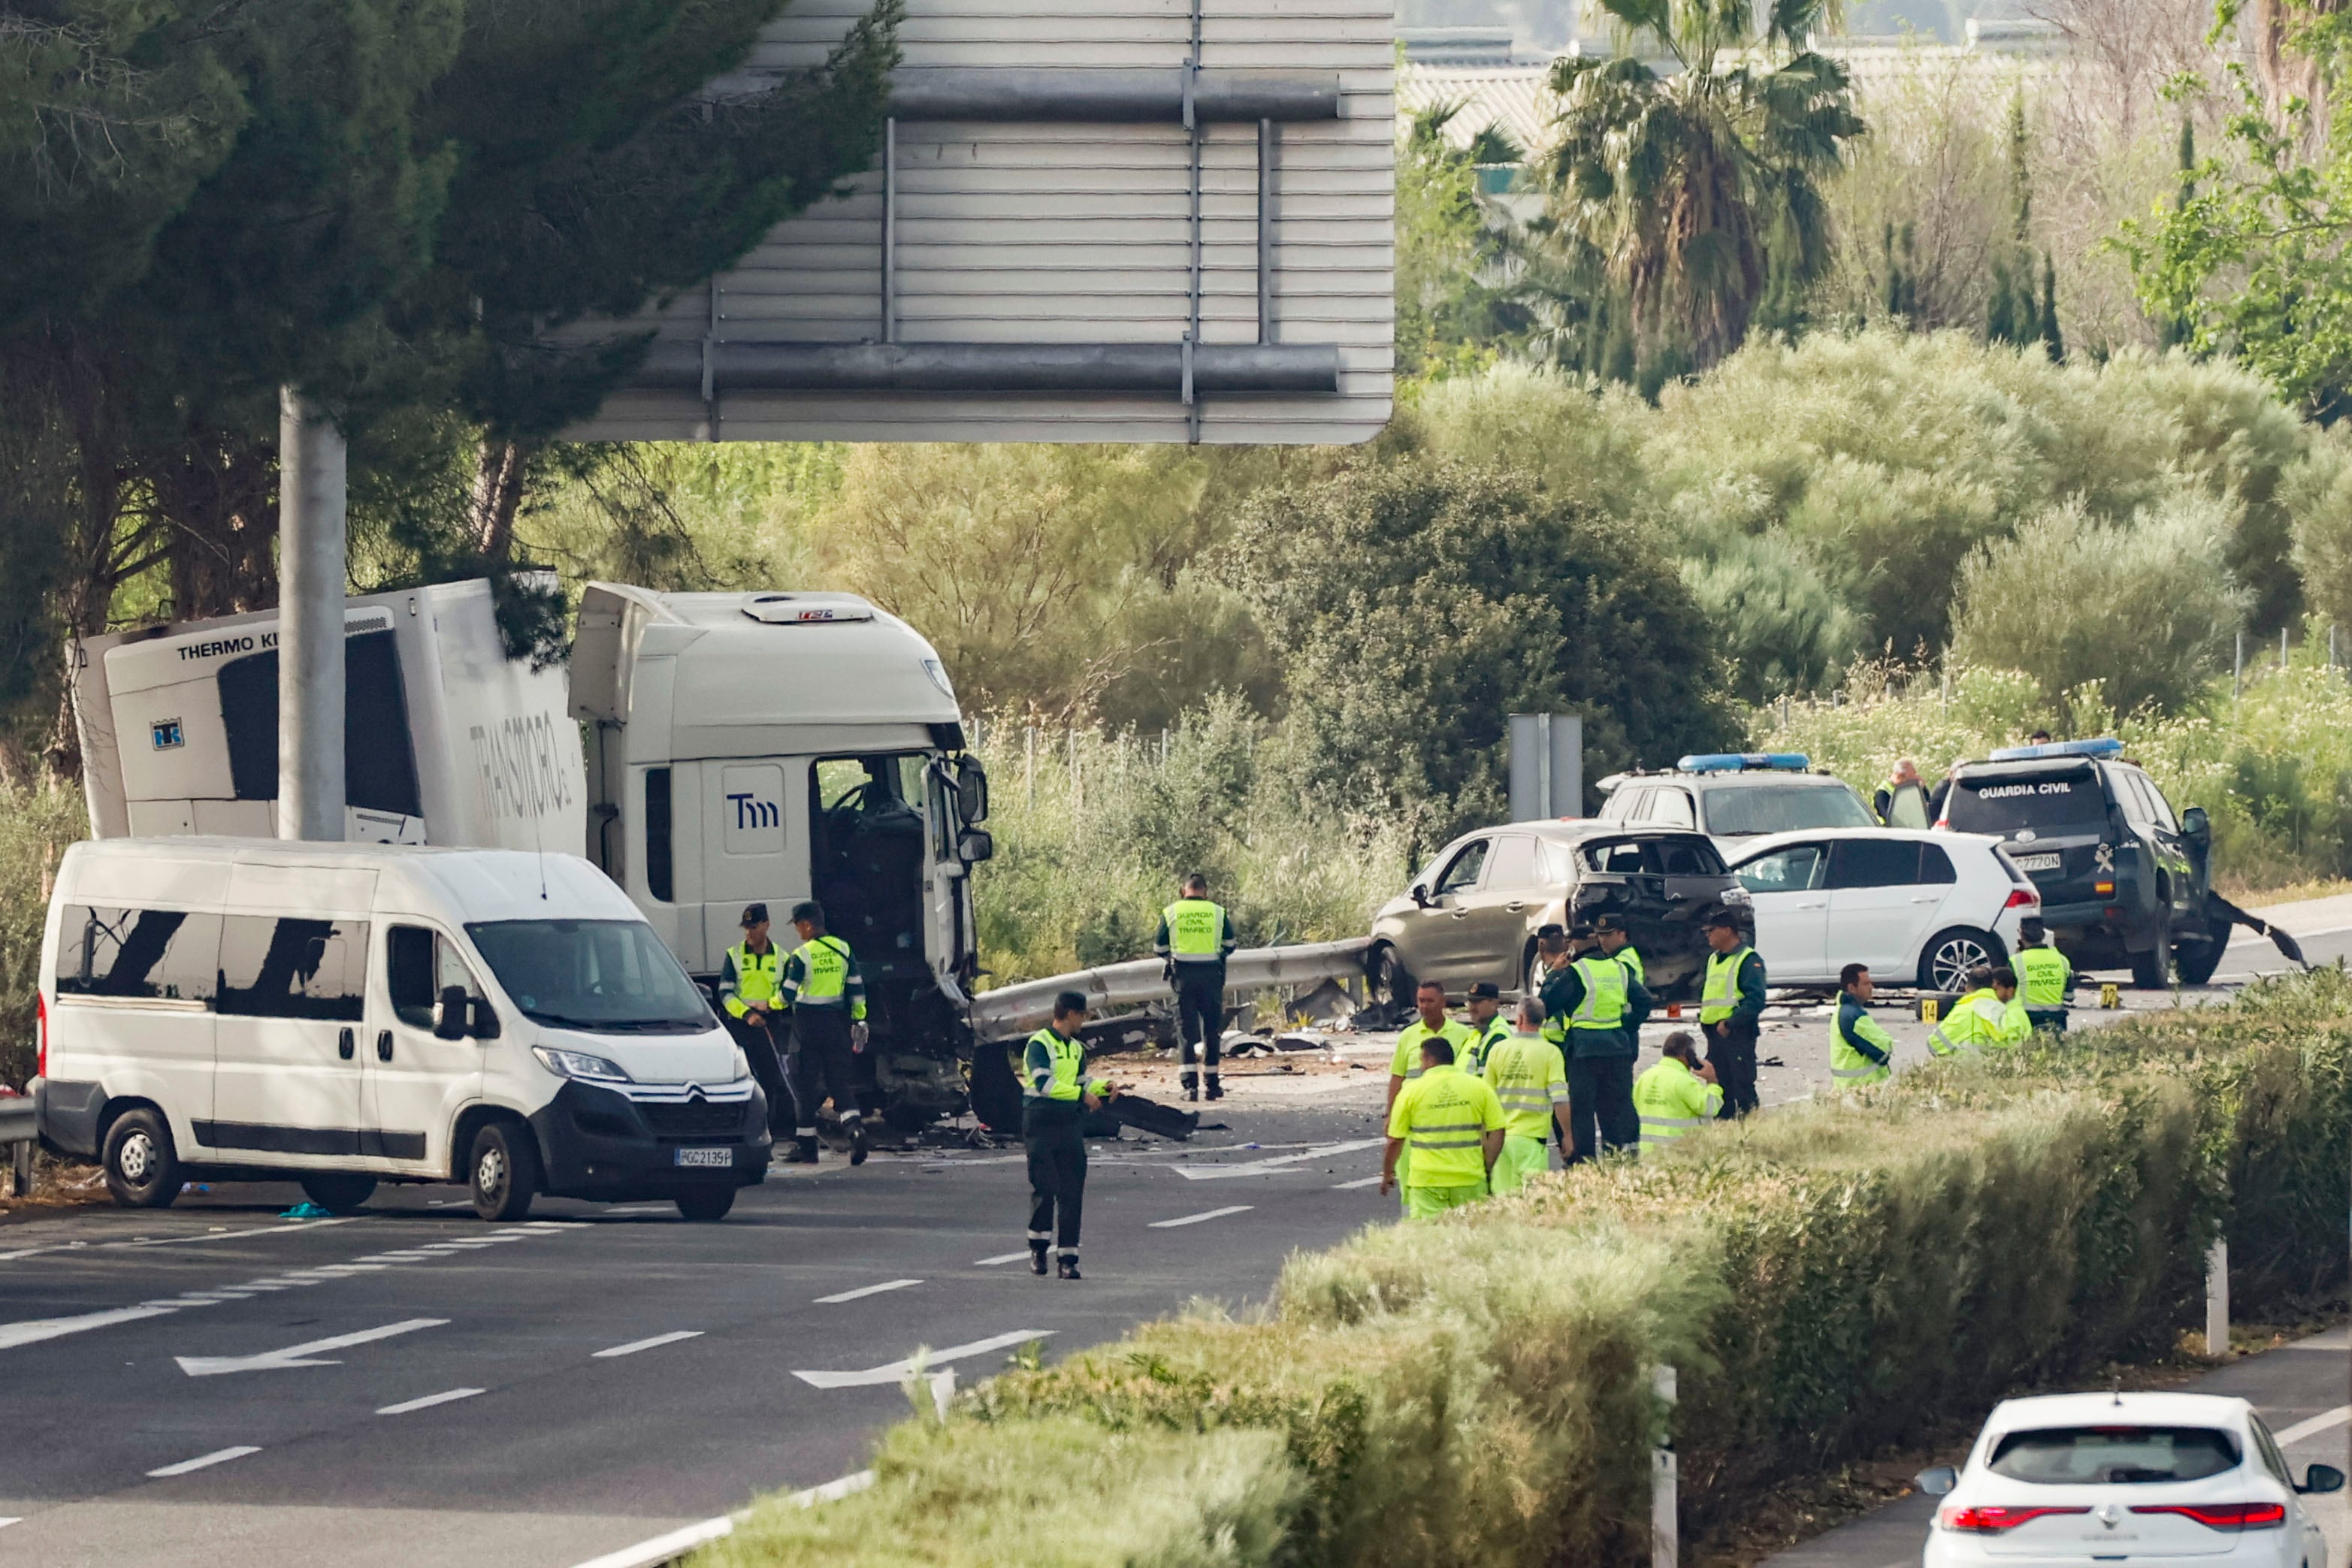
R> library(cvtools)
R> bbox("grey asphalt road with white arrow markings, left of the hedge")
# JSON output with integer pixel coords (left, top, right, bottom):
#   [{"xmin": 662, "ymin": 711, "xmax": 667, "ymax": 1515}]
[{"xmin": 0, "ymin": 898, "xmax": 2352, "ymax": 1568}]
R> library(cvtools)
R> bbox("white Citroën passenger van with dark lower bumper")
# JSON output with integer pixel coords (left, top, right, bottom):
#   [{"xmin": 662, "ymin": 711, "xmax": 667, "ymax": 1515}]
[{"xmin": 33, "ymin": 837, "xmax": 772, "ymax": 1220}]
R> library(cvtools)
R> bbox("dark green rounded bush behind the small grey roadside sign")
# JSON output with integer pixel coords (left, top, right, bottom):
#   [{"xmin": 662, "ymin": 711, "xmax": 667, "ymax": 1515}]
[{"xmin": 1228, "ymin": 456, "xmax": 1729, "ymax": 846}]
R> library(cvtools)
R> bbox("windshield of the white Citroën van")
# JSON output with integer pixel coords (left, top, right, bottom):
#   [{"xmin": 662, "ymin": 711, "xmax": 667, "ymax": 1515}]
[{"xmin": 466, "ymin": 919, "xmax": 718, "ymax": 1035}]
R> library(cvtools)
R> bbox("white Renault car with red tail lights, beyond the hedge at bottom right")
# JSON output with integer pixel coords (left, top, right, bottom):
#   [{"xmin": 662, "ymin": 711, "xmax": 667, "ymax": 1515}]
[{"xmin": 1919, "ymin": 1394, "xmax": 2345, "ymax": 1568}]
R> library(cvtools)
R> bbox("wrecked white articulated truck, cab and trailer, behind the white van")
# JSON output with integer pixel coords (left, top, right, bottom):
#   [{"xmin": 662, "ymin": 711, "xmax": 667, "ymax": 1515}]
[{"xmin": 73, "ymin": 581, "xmax": 993, "ymax": 1128}]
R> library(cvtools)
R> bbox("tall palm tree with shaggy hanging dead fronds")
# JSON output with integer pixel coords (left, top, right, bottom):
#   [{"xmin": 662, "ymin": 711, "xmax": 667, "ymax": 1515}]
[{"xmin": 1538, "ymin": 0, "xmax": 1867, "ymax": 369}]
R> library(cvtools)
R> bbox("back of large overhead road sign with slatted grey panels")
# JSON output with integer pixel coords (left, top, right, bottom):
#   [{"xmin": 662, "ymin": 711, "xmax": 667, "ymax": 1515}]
[{"xmin": 574, "ymin": 0, "xmax": 1395, "ymax": 442}]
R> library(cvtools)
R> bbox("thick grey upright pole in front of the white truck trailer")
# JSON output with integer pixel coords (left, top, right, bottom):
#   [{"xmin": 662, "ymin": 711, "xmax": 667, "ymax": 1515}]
[{"xmin": 277, "ymin": 388, "xmax": 346, "ymax": 839}]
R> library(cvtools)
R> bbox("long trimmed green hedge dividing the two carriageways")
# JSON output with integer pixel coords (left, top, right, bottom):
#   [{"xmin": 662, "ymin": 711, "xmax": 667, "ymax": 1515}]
[{"xmin": 694, "ymin": 971, "xmax": 2352, "ymax": 1568}]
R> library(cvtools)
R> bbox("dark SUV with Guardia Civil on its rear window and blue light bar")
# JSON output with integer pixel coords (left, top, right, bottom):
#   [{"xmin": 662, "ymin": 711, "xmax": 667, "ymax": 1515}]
[{"xmin": 1936, "ymin": 738, "xmax": 2230, "ymax": 987}]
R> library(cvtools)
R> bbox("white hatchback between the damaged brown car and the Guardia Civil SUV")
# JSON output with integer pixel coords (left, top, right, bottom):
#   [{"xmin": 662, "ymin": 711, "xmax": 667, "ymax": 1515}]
[{"xmin": 1731, "ymin": 827, "xmax": 2042, "ymax": 992}]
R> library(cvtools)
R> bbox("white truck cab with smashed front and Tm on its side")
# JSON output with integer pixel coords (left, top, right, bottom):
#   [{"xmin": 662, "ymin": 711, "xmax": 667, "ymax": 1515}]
[{"xmin": 572, "ymin": 583, "xmax": 993, "ymax": 1131}]
